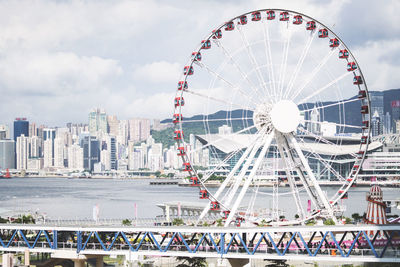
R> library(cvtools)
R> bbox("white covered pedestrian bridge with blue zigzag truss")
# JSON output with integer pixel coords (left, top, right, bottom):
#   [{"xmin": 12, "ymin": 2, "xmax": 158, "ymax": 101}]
[{"xmin": 0, "ymin": 224, "xmax": 400, "ymax": 262}]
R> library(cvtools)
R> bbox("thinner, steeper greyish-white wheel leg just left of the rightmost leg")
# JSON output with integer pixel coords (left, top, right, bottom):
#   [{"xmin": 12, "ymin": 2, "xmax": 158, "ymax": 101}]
[{"xmin": 275, "ymin": 133, "xmax": 306, "ymax": 222}]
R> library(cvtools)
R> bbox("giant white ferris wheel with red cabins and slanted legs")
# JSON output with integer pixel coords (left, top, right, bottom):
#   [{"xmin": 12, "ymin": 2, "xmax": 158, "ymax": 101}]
[{"xmin": 173, "ymin": 9, "xmax": 370, "ymax": 226}]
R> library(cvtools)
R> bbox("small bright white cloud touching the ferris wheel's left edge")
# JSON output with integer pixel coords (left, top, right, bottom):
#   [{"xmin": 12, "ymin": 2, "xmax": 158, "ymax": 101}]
[{"xmin": 133, "ymin": 61, "xmax": 182, "ymax": 83}]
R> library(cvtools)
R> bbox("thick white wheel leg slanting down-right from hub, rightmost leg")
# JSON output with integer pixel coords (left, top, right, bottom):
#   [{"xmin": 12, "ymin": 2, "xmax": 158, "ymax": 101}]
[{"xmin": 289, "ymin": 134, "xmax": 337, "ymax": 223}]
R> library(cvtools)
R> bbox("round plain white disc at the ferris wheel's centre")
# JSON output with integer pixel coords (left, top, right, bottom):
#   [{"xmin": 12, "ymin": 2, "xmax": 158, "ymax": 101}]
[{"xmin": 270, "ymin": 100, "xmax": 301, "ymax": 133}]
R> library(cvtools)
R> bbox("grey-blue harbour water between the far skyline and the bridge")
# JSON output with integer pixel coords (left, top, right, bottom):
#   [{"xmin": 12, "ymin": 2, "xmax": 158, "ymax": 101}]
[{"xmin": 0, "ymin": 178, "xmax": 400, "ymax": 222}]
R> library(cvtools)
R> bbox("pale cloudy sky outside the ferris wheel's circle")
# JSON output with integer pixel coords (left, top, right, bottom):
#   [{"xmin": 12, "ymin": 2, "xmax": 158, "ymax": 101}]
[{"xmin": 0, "ymin": 0, "xmax": 400, "ymax": 126}]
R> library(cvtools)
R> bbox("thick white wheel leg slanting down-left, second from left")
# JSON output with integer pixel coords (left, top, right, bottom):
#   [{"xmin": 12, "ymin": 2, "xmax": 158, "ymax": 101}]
[{"xmin": 225, "ymin": 132, "xmax": 274, "ymax": 227}]
